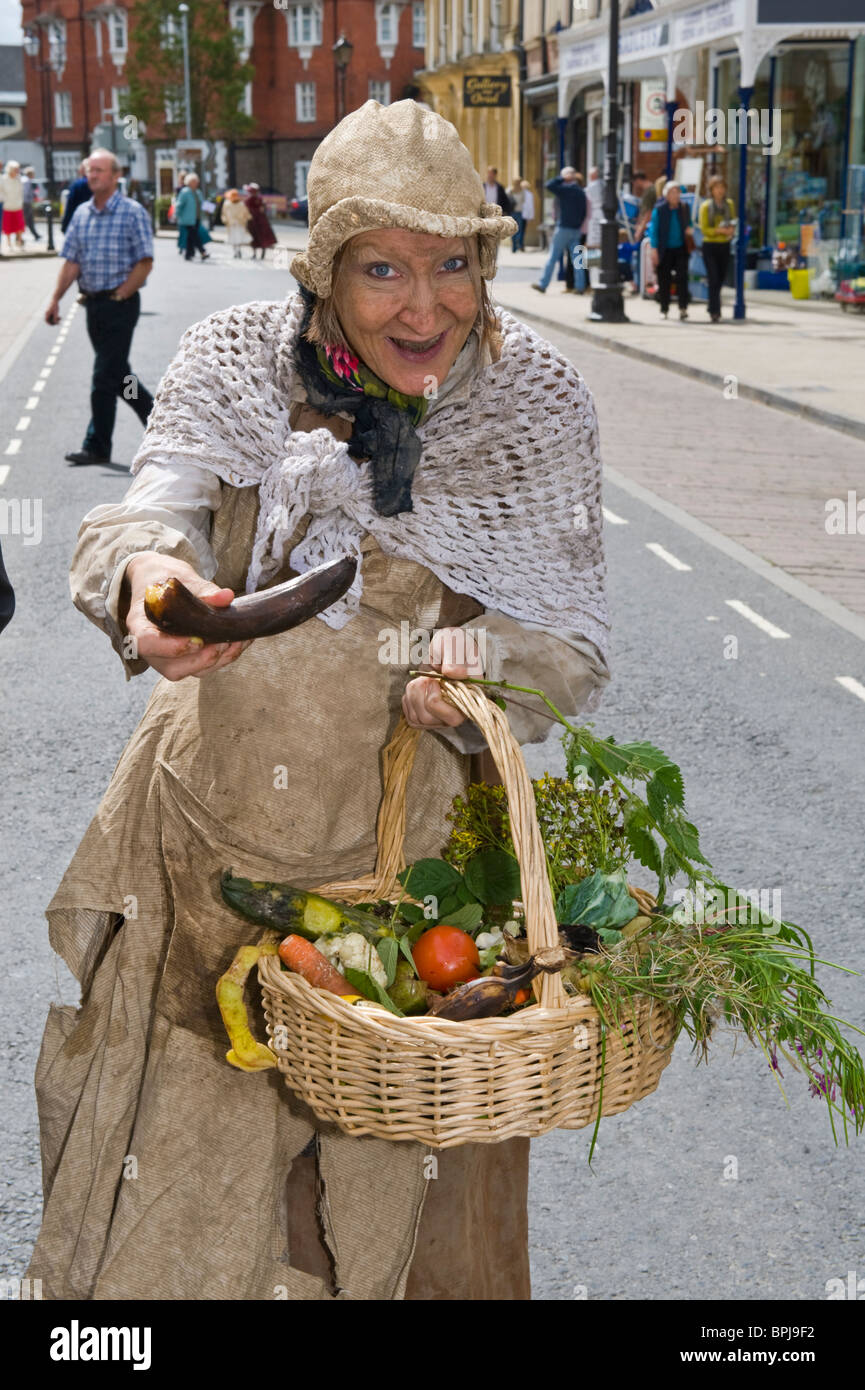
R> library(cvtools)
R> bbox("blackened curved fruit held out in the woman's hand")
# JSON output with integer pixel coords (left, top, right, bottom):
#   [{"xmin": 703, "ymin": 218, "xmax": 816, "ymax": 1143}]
[{"xmin": 145, "ymin": 555, "xmax": 357, "ymax": 642}]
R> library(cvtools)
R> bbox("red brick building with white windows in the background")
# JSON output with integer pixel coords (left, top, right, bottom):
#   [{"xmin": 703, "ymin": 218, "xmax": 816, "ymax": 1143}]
[{"xmin": 22, "ymin": 0, "xmax": 426, "ymax": 197}]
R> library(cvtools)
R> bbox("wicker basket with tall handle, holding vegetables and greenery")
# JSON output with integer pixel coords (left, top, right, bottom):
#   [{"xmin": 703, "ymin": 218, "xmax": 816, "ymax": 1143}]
[{"xmin": 259, "ymin": 681, "xmax": 674, "ymax": 1148}]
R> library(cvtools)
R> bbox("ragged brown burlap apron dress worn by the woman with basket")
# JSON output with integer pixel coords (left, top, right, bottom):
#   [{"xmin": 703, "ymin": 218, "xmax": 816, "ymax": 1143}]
[{"xmin": 28, "ymin": 487, "xmax": 530, "ymax": 1300}]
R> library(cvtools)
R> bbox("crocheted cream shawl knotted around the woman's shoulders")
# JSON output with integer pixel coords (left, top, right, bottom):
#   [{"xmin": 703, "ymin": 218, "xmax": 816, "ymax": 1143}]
[{"xmin": 132, "ymin": 295, "xmax": 608, "ymax": 656}]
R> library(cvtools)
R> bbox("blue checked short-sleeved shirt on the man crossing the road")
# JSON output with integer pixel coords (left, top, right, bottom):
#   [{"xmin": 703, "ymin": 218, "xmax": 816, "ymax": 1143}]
[{"xmin": 60, "ymin": 189, "xmax": 153, "ymax": 293}]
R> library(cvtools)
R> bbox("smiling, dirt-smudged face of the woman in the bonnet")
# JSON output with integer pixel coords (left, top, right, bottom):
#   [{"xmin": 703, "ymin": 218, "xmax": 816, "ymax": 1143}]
[{"xmin": 334, "ymin": 228, "xmax": 480, "ymax": 396}]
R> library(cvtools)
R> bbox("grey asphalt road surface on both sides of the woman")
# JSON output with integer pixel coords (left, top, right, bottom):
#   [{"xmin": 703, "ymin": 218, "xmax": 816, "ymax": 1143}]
[{"xmin": 0, "ymin": 240, "xmax": 865, "ymax": 1301}]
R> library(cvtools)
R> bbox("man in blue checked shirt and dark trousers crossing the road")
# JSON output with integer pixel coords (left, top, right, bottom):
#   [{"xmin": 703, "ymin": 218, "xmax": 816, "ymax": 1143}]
[{"xmin": 45, "ymin": 150, "xmax": 153, "ymax": 463}]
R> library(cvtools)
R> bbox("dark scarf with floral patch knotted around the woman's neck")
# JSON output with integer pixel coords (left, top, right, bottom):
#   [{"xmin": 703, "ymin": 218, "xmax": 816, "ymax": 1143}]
[{"xmin": 293, "ymin": 286, "xmax": 430, "ymax": 517}]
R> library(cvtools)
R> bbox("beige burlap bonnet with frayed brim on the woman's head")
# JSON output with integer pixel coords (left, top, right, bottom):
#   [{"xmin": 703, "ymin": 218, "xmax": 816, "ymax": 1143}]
[{"xmin": 291, "ymin": 101, "xmax": 517, "ymax": 299}]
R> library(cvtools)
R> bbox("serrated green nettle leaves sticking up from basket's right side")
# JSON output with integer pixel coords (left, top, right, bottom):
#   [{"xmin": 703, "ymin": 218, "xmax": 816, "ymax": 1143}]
[{"xmin": 562, "ymin": 728, "xmax": 708, "ymax": 899}]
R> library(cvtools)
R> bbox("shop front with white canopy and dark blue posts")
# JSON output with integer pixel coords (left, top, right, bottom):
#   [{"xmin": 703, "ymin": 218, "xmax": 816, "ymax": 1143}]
[{"xmin": 559, "ymin": 0, "xmax": 865, "ymax": 317}]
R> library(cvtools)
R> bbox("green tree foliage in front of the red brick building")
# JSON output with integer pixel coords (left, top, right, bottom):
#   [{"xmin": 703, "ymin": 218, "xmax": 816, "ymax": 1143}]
[{"xmin": 127, "ymin": 0, "xmax": 254, "ymax": 139}]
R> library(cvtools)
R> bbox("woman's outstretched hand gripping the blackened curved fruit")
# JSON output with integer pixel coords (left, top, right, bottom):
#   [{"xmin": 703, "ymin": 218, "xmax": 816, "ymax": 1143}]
[{"xmin": 125, "ymin": 550, "xmax": 249, "ymax": 681}]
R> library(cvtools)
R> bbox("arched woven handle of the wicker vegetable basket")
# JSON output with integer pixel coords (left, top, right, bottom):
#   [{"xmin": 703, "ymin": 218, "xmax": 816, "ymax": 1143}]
[{"xmin": 374, "ymin": 680, "xmax": 567, "ymax": 1008}]
